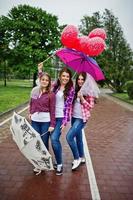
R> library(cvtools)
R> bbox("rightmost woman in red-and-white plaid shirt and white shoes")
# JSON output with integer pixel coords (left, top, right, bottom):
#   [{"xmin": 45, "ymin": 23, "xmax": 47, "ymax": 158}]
[{"xmin": 66, "ymin": 72, "xmax": 99, "ymax": 170}]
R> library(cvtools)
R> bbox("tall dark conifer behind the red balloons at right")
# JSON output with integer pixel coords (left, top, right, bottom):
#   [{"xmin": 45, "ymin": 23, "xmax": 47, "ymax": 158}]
[{"xmin": 81, "ymin": 9, "xmax": 133, "ymax": 92}]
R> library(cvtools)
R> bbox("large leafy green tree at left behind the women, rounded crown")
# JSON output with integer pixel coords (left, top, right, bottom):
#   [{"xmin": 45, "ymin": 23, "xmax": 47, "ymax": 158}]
[{"xmin": 2, "ymin": 5, "xmax": 60, "ymax": 85}]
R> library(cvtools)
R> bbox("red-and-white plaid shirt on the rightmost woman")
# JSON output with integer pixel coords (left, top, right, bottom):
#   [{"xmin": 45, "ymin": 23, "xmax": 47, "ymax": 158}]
[{"xmin": 81, "ymin": 96, "xmax": 95, "ymax": 122}]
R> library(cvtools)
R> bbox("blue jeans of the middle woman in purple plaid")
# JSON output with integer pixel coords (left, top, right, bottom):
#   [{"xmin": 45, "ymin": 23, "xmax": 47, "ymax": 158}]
[{"xmin": 51, "ymin": 118, "xmax": 63, "ymax": 165}]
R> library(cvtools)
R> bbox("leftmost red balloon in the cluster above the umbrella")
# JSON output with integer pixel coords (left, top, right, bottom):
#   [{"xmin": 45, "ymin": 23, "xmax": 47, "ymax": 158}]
[{"xmin": 61, "ymin": 25, "xmax": 79, "ymax": 48}]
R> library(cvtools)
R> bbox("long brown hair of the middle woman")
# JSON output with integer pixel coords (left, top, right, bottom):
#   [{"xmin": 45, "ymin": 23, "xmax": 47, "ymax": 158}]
[{"xmin": 53, "ymin": 67, "xmax": 73, "ymax": 100}]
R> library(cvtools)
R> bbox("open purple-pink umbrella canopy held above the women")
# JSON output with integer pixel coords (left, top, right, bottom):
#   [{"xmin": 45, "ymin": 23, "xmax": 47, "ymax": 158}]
[{"xmin": 55, "ymin": 48, "xmax": 105, "ymax": 81}]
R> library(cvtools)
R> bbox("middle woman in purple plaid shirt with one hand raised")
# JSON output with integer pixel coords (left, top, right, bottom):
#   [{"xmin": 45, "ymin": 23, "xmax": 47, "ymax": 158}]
[{"xmin": 38, "ymin": 63, "xmax": 74, "ymax": 175}]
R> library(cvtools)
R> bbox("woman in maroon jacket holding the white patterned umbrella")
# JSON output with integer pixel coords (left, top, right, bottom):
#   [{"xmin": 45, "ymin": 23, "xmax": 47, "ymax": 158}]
[{"xmin": 29, "ymin": 73, "xmax": 56, "ymax": 152}]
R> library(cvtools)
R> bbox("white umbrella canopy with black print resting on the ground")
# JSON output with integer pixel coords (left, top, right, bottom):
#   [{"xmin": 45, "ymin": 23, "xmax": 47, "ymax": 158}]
[{"xmin": 10, "ymin": 112, "xmax": 53, "ymax": 171}]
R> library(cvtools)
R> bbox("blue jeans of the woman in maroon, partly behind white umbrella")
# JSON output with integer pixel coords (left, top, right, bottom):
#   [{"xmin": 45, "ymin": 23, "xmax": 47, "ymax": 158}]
[{"xmin": 31, "ymin": 121, "xmax": 50, "ymax": 149}]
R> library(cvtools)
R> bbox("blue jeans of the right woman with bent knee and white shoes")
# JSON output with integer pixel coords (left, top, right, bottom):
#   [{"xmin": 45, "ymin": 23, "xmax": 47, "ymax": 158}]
[{"xmin": 66, "ymin": 117, "xmax": 86, "ymax": 159}]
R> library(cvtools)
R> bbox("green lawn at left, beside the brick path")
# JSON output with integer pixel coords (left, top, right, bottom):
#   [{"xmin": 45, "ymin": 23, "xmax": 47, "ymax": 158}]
[{"xmin": 0, "ymin": 85, "xmax": 32, "ymax": 114}]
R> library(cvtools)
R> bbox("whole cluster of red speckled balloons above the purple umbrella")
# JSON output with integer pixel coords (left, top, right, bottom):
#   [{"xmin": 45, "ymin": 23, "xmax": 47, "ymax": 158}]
[{"xmin": 61, "ymin": 25, "xmax": 106, "ymax": 56}]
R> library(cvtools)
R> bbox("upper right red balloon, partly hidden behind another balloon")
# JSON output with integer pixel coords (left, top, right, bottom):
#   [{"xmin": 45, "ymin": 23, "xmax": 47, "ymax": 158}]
[{"xmin": 88, "ymin": 28, "xmax": 107, "ymax": 40}]
